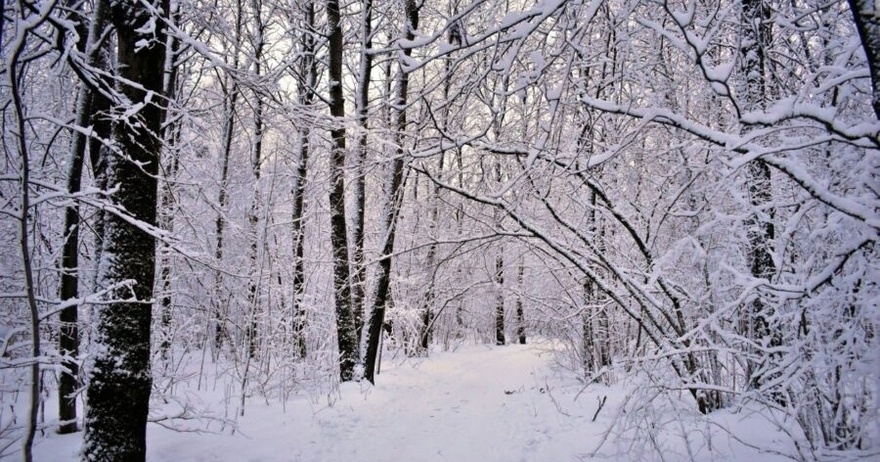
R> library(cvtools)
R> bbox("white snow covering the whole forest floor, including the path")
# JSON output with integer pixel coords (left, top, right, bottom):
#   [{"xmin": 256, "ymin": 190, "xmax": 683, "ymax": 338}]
[{"xmin": 27, "ymin": 343, "xmax": 793, "ymax": 462}]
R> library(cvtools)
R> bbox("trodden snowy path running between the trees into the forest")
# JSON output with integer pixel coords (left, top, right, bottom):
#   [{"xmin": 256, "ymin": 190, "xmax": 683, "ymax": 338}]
[{"xmin": 292, "ymin": 347, "xmax": 576, "ymax": 461}]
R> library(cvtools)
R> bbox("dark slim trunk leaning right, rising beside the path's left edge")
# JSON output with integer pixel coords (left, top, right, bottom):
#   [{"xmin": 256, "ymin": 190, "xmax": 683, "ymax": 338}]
[{"xmin": 364, "ymin": 0, "xmax": 419, "ymax": 383}]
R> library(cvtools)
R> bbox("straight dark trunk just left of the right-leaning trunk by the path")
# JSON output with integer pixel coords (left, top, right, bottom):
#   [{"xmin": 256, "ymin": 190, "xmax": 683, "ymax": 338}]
[{"xmin": 327, "ymin": 0, "xmax": 358, "ymax": 382}]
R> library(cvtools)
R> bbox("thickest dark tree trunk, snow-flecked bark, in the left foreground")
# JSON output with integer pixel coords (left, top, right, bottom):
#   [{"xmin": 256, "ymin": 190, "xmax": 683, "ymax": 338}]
[{"xmin": 82, "ymin": 0, "xmax": 168, "ymax": 461}]
